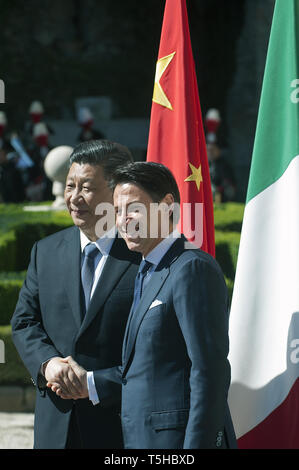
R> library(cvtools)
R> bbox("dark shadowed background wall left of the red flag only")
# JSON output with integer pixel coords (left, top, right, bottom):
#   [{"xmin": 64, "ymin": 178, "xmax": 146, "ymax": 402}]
[{"xmin": 0, "ymin": 0, "xmax": 163, "ymax": 125}]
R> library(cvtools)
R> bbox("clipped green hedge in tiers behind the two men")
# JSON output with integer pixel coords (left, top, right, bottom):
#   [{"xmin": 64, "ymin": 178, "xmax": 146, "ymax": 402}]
[{"xmin": 0, "ymin": 203, "xmax": 244, "ymax": 385}]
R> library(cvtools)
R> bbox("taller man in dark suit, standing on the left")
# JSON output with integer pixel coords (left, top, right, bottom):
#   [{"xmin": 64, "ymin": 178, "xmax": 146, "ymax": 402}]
[{"xmin": 11, "ymin": 140, "xmax": 140, "ymax": 449}]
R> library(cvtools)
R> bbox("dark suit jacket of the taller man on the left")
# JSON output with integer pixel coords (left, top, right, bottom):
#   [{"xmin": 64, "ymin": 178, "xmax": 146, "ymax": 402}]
[{"xmin": 11, "ymin": 227, "xmax": 140, "ymax": 449}]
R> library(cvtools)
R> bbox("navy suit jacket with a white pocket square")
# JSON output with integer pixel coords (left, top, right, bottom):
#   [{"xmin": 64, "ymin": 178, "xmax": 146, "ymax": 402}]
[{"xmin": 95, "ymin": 238, "xmax": 236, "ymax": 449}]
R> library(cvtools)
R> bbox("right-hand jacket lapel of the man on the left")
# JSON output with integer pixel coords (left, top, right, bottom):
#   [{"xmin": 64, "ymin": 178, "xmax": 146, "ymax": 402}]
[{"xmin": 77, "ymin": 237, "xmax": 138, "ymax": 338}]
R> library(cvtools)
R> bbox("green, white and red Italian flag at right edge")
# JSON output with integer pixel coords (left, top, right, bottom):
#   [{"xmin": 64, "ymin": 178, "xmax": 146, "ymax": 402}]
[{"xmin": 229, "ymin": 0, "xmax": 299, "ymax": 449}]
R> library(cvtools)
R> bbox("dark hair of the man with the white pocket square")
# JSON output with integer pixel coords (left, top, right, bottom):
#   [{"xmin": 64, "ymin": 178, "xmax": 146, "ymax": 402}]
[{"xmin": 110, "ymin": 162, "xmax": 180, "ymax": 203}]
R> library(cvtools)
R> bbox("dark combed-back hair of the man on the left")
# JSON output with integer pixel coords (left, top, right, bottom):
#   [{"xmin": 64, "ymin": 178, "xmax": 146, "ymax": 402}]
[{"xmin": 70, "ymin": 139, "xmax": 133, "ymax": 181}]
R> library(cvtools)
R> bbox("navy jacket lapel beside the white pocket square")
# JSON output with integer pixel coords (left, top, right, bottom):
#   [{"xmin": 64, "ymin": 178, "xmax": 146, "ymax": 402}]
[{"xmin": 123, "ymin": 237, "xmax": 186, "ymax": 374}]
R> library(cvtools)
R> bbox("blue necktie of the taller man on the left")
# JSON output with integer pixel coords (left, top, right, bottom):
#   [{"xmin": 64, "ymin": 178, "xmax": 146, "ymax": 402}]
[{"xmin": 81, "ymin": 243, "xmax": 101, "ymax": 312}]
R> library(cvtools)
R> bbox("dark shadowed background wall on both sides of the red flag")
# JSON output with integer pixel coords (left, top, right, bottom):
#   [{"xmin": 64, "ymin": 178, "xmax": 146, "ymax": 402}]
[{"xmin": 0, "ymin": 0, "xmax": 274, "ymax": 200}]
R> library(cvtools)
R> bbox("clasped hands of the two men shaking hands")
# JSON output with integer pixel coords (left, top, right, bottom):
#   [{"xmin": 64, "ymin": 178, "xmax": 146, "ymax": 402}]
[{"xmin": 44, "ymin": 356, "xmax": 88, "ymax": 400}]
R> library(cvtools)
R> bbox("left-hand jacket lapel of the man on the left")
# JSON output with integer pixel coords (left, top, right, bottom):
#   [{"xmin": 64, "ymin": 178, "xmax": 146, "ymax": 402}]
[{"xmin": 60, "ymin": 227, "xmax": 82, "ymax": 329}]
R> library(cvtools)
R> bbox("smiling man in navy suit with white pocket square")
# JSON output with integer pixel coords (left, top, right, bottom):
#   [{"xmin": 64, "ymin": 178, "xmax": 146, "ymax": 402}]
[{"xmin": 61, "ymin": 162, "xmax": 236, "ymax": 449}]
